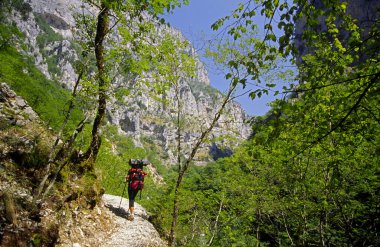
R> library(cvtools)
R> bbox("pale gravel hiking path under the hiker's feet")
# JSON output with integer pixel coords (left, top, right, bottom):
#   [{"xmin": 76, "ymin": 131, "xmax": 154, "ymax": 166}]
[{"xmin": 103, "ymin": 194, "xmax": 167, "ymax": 247}]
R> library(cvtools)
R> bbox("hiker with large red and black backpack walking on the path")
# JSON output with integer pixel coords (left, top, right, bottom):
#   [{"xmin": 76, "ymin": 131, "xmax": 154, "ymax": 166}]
[{"xmin": 125, "ymin": 159, "xmax": 150, "ymax": 221}]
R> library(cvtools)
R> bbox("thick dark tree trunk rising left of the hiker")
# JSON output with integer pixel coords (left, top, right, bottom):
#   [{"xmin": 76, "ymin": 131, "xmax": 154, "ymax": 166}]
[{"xmin": 81, "ymin": 2, "xmax": 110, "ymax": 166}]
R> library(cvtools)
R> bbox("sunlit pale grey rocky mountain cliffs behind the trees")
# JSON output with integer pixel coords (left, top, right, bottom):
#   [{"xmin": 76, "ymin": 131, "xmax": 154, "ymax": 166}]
[{"xmin": 8, "ymin": 0, "xmax": 250, "ymax": 163}]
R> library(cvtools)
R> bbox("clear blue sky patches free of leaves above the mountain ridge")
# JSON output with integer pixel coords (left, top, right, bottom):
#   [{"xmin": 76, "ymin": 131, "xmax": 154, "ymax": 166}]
[{"xmin": 165, "ymin": 0, "xmax": 280, "ymax": 116}]
